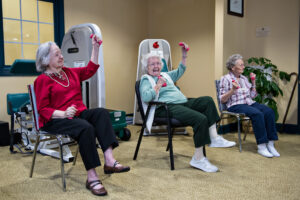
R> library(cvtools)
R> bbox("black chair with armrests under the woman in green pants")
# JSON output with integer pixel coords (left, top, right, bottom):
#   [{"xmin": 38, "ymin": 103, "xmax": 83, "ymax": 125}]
[{"xmin": 133, "ymin": 80, "xmax": 206, "ymax": 170}]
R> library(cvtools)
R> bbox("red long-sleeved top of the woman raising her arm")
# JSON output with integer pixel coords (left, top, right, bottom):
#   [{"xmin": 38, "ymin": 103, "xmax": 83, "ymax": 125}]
[{"xmin": 34, "ymin": 61, "xmax": 99, "ymax": 128}]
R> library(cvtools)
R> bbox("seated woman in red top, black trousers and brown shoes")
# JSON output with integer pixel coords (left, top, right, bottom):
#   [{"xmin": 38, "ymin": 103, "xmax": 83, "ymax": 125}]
[{"xmin": 34, "ymin": 36, "xmax": 130, "ymax": 196}]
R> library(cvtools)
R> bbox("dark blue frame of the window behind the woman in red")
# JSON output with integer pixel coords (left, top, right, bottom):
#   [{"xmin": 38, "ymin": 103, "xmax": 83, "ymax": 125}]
[{"xmin": 0, "ymin": 0, "xmax": 65, "ymax": 76}]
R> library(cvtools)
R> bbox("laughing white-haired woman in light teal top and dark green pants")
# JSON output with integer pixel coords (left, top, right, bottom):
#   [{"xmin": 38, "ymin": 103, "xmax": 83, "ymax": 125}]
[{"xmin": 140, "ymin": 41, "xmax": 235, "ymax": 172}]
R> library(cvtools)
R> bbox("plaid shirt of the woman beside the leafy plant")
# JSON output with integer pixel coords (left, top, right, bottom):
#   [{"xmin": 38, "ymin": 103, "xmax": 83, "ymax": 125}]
[{"xmin": 219, "ymin": 72, "xmax": 257, "ymax": 108}]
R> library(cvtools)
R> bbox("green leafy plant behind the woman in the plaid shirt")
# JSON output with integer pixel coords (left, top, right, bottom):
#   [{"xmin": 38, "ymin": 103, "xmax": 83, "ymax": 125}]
[{"xmin": 243, "ymin": 57, "xmax": 291, "ymax": 121}]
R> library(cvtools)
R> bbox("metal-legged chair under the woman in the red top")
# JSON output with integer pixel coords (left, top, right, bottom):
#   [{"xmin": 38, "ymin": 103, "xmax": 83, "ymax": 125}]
[{"xmin": 27, "ymin": 84, "xmax": 79, "ymax": 191}]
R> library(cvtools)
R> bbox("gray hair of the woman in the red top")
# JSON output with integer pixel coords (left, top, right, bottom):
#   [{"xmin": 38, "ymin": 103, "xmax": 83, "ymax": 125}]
[{"xmin": 35, "ymin": 42, "xmax": 56, "ymax": 72}]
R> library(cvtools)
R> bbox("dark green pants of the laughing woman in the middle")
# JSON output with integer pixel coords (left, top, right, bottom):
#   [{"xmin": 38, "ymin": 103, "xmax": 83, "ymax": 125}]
[{"xmin": 155, "ymin": 96, "xmax": 220, "ymax": 148}]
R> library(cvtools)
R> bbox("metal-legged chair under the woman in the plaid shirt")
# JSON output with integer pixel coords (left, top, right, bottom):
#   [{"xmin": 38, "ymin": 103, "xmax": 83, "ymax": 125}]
[{"xmin": 215, "ymin": 80, "xmax": 251, "ymax": 152}]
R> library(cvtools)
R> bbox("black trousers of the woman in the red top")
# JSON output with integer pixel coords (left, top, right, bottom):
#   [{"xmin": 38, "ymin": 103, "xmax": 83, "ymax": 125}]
[{"xmin": 42, "ymin": 108, "xmax": 119, "ymax": 170}]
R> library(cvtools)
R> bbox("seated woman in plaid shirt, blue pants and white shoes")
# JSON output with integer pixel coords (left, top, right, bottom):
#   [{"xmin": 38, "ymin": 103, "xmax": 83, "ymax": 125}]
[{"xmin": 219, "ymin": 54, "xmax": 280, "ymax": 157}]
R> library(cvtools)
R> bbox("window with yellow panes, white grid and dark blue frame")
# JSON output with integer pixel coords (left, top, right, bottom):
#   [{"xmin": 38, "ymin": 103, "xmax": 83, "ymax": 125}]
[{"xmin": 0, "ymin": 0, "xmax": 64, "ymax": 76}]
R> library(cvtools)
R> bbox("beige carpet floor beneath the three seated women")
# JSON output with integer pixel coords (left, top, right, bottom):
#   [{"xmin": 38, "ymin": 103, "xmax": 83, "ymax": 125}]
[{"xmin": 0, "ymin": 126, "xmax": 300, "ymax": 200}]
